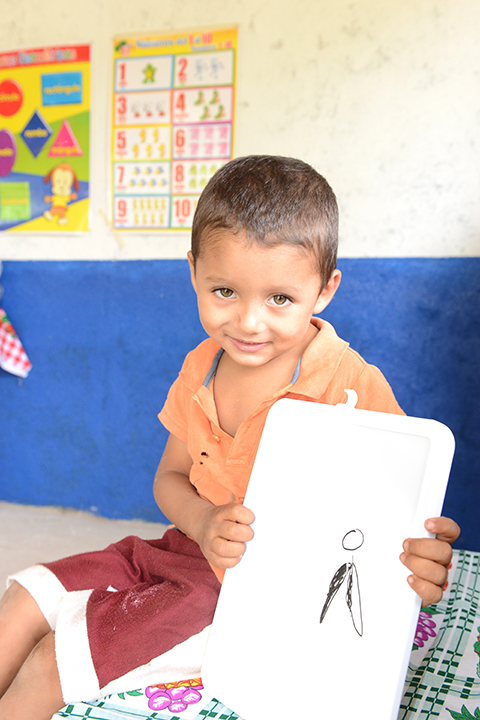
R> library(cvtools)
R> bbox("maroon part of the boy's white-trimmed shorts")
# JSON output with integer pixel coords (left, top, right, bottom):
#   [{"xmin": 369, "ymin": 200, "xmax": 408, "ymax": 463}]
[{"xmin": 25, "ymin": 529, "xmax": 221, "ymax": 701}]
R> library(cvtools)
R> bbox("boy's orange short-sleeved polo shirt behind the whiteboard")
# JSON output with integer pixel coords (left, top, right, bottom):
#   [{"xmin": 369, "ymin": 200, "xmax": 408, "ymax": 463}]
[{"xmin": 158, "ymin": 317, "xmax": 403, "ymax": 572}]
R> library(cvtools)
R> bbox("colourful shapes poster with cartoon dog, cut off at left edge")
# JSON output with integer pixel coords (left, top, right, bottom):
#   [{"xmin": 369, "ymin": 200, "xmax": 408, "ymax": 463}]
[{"xmin": 0, "ymin": 45, "xmax": 90, "ymax": 233}]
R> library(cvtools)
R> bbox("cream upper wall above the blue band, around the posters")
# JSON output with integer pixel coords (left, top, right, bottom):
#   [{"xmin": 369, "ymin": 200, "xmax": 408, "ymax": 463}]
[{"xmin": 0, "ymin": 0, "xmax": 480, "ymax": 260}]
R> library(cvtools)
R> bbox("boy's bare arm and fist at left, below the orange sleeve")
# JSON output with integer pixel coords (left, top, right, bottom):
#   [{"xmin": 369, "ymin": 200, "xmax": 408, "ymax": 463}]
[{"xmin": 153, "ymin": 435, "xmax": 254, "ymax": 568}]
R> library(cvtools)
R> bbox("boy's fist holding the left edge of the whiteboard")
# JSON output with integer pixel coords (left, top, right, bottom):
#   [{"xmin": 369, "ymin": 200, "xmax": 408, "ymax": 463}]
[{"xmin": 194, "ymin": 503, "xmax": 255, "ymax": 568}]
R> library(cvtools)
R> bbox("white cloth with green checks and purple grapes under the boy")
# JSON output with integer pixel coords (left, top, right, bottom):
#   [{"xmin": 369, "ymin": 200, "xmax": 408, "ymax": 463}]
[{"xmin": 52, "ymin": 550, "xmax": 480, "ymax": 720}]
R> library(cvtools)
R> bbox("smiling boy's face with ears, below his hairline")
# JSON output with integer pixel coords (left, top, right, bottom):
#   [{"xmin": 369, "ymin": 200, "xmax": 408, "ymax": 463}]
[{"xmin": 189, "ymin": 230, "xmax": 340, "ymax": 367}]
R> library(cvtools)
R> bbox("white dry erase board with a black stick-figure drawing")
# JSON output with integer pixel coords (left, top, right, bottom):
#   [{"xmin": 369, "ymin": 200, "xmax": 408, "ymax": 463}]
[{"xmin": 202, "ymin": 391, "xmax": 454, "ymax": 720}]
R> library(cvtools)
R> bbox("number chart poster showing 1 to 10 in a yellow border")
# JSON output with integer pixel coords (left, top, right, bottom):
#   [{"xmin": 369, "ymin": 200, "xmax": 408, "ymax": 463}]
[{"xmin": 111, "ymin": 28, "xmax": 237, "ymax": 231}]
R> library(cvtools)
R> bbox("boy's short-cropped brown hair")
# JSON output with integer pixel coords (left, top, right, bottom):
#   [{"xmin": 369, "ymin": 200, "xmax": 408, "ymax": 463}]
[{"xmin": 192, "ymin": 155, "xmax": 338, "ymax": 286}]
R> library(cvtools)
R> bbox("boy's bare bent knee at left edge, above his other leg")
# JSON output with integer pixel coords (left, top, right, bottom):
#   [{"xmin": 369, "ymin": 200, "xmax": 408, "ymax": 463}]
[{"xmin": 0, "ymin": 582, "xmax": 50, "ymax": 698}]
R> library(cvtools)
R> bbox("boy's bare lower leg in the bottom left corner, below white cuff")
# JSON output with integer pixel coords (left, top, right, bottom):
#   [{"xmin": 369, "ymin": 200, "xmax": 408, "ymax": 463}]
[{"xmin": 0, "ymin": 631, "xmax": 65, "ymax": 720}]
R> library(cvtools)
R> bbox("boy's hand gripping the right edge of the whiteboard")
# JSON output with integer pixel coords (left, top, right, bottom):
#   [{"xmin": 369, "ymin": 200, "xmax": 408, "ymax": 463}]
[{"xmin": 400, "ymin": 517, "xmax": 460, "ymax": 607}]
